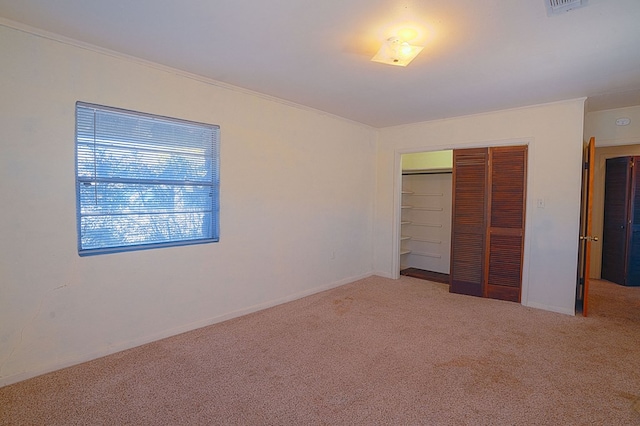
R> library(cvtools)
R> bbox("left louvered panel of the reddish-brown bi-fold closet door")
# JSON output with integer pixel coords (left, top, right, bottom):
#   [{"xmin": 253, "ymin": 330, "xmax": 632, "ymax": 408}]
[{"xmin": 449, "ymin": 148, "xmax": 488, "ymax": 296}]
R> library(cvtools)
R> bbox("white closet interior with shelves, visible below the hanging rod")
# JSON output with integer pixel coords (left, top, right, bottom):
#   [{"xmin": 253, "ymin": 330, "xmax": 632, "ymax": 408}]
[{"xmin": 400, "ymin": 169, "xmax": 451, "ymax": 274}]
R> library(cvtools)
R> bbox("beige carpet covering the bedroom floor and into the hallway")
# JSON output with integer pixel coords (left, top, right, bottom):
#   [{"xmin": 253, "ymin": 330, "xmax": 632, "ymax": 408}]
[{"xmin": 0, "ymin": 277, "xmax": 640, "ymax": 425}]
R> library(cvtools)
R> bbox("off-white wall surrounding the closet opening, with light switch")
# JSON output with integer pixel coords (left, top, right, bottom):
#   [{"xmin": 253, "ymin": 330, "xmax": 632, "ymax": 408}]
[{"xmin": 374, "ymin": 99, "xmax": 584, "ymax": 314}]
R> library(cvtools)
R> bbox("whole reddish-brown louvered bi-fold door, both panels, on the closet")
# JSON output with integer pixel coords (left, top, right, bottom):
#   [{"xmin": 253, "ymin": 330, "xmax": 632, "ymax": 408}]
[{"xmin": 450, "ymin": 146, "xmax": 527, "ymax": 302}]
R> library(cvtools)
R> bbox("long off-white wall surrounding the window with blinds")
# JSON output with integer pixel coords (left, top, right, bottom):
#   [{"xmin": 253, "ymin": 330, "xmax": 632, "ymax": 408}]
[{"xmin": 0, "ymin": 25, "xmax": 375, "ymax": 386}]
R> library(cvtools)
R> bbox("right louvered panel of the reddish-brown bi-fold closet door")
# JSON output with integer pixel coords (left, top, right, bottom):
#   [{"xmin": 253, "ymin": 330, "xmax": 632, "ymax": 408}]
[{"xmin": 484, "ymin": 146, "xmax": 527, "ymax": 302}]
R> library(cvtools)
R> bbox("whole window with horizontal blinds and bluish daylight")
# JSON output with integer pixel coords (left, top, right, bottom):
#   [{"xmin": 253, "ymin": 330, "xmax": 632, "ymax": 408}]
[{"xmin": 76, "ymin": 102, "xmax": 220, "ymax": 256}]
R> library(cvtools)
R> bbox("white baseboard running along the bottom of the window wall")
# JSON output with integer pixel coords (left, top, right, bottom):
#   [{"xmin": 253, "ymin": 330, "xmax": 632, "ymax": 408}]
[{"xmin": 0, "ymin": 273, "xmax": 373, "ymax": 387}]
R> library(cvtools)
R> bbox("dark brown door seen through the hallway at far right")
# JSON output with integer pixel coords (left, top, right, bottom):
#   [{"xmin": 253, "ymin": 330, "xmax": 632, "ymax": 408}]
[{"xmin": 602, "ymin": 157, "xmax": 640, "ymax": 286}]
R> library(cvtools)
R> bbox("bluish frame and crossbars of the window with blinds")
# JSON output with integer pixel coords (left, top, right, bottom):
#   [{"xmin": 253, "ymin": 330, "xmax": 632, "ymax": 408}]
[{"xmin": 74, "ymin": 101, "xmax": 220, "ymax": 256}]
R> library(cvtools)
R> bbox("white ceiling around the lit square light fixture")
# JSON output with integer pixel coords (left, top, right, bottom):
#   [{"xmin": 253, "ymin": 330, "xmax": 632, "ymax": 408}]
[{"xmin": 0, "ymin": 0, "xmax": 640, "ymax": 127}]
